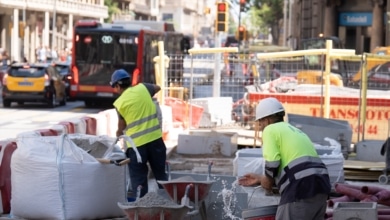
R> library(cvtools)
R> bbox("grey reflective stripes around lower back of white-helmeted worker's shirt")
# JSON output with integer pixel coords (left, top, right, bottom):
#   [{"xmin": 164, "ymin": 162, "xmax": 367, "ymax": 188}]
[{"xmin": 277, "ymin": 156, "xmax": 328, "ymax": 192}]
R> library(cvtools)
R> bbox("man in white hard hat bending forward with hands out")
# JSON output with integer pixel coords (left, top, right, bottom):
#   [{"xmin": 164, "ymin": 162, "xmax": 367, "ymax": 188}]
[{"xmin": 238, "ymin": 98, "xmax": 331, "ymax": 220}]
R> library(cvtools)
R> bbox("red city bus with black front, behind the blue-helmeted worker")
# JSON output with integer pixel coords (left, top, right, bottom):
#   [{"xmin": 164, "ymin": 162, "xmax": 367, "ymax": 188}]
[{"xmin": 70, "ymin": 20, "xmax": 189, "ymax": 107}]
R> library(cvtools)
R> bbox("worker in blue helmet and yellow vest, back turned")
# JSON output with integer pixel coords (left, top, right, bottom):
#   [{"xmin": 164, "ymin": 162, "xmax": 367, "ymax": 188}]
[{"xmin": 110, "ymin": 69, "xmax": 168, "ymax": 197}]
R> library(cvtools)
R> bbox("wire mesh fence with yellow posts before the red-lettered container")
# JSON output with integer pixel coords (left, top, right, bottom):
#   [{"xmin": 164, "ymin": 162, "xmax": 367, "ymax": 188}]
[{"xmin": 162, "ymin": 42, "xmax": 390, "ymax": 143}]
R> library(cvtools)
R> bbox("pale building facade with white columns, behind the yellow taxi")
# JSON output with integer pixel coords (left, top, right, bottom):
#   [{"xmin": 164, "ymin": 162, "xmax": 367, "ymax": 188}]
[{"xmin": 0, "ymin": 0, "xmax": 108, "ymax": 62}]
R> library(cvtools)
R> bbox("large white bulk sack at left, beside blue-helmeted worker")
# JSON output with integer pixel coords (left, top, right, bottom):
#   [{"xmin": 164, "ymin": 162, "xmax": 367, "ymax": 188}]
[{"xmin": 11, "ymin": 135, "xmax": 127, "ymax": 220}]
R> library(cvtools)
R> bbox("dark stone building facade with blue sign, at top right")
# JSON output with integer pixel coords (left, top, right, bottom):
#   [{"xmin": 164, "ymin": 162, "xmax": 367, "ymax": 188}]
[{"xmin": 290, "ymin": 0, "xmax": 390, "ymax": 53}]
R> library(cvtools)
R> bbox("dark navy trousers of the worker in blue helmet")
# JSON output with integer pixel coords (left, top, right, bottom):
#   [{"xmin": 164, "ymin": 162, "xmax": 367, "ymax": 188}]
[{"xmin": 126, "ymin": 138, "xmax": 168, "ymax": 197}]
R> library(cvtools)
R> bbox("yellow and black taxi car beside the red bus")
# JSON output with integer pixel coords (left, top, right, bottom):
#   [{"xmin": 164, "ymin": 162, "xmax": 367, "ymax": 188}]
[{"xmin": 2, "ymin": 63, "xmax": 66, "ymax": 107}]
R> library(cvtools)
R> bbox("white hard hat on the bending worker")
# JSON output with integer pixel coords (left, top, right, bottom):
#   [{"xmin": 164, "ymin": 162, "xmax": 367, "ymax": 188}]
[{"xmin": 255, "ymin": 97, "xmax": 284, "ymax": 121}]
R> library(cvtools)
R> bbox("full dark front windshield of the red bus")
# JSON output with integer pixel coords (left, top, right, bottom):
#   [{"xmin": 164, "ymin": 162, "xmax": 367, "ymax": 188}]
[{"xmin": 74, "ymin": 31, "xmax": 138, "ymax": 86}]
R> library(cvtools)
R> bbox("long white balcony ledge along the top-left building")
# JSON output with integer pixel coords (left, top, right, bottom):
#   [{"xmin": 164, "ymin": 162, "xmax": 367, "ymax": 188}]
[{"xmin": 0, "ymin": 0, "xmax": 108, "ymax": 18}]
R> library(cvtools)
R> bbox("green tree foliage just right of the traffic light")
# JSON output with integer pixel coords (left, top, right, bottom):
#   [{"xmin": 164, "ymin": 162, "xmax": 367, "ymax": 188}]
[{"xmin": 252, "ymin": 0, "xmax": 283, "ymax": 45}]
